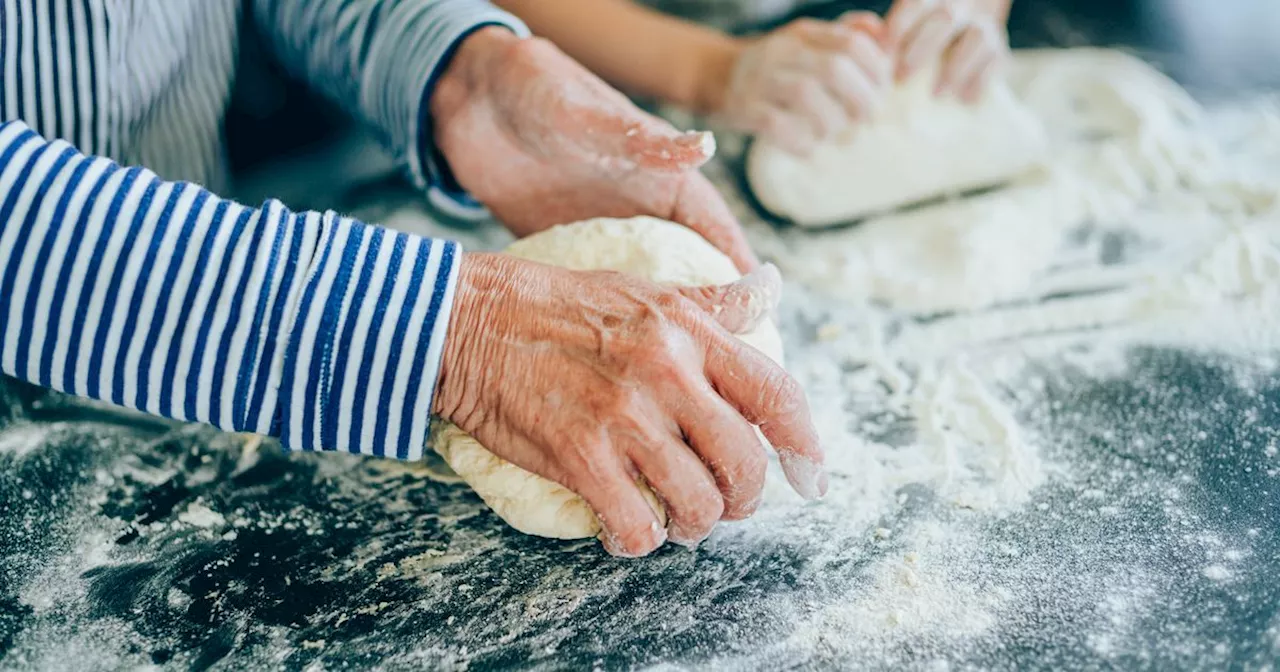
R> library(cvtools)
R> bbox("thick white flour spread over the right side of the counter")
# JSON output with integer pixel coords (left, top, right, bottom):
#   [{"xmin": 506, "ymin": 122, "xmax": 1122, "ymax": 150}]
[{"xmin": 696, "ymin": 50, "xmax": 1280, "ymax": 664}]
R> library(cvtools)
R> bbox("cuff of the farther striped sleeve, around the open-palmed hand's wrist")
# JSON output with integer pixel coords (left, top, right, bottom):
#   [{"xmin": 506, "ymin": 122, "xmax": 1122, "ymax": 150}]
[{"xmin": 361, "ymin": 0, "xmax": 530, "ymax": 216}]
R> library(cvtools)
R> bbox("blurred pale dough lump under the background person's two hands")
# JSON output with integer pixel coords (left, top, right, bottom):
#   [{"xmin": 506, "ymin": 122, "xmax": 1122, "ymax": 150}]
[{"xmin": 746, "ymin": 70, "xmax": 1048, "ymax": 227}]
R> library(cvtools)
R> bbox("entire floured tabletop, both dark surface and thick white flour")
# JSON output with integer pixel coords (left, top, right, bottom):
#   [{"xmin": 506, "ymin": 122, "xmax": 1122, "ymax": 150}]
[{"xmin": 0, "ymin": 35, "xmax": 1280, "ymax": 669}]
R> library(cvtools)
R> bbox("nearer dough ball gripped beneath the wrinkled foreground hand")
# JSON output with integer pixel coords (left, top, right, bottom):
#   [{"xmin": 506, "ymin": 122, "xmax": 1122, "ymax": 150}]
[{"xmin": 431, "ymin": 218, "xmax": 782, "ymax": 539}]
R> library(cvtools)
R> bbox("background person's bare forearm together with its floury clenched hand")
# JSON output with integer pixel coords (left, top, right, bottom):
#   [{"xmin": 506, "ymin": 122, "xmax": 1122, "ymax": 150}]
[{"xmin": 497, "ymin": 0, "xmax": 890, "ymax": 154}]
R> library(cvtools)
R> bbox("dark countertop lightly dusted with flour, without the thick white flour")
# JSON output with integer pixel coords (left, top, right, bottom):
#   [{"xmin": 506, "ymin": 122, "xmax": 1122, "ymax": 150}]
[{"xmin": 0, "ymin": 0, "xmax": 1280, "ymax": 669}]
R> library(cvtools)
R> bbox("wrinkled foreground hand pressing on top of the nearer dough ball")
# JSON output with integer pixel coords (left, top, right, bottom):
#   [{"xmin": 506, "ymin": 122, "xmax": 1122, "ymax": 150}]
[{"xmin": 435, "ymin": 253, "xmax": 827, "ymax": 557}]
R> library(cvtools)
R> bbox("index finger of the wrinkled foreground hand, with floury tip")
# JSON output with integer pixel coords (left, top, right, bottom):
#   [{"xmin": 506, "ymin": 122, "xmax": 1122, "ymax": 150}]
[{"xmin": 707, "ymin": 333, "xmax": 827, "ymax": 499}]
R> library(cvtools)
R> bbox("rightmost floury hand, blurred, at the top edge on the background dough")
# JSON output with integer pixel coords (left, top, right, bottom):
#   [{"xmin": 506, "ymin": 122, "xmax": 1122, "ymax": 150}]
[{"xmin": 884, "ymin": 0, "xmax": 1009, "ymax": 102}]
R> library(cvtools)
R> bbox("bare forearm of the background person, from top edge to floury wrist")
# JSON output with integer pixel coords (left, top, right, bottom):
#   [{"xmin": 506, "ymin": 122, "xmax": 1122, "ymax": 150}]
[{"xmin": 494, "ymin": 0, "xmax": 741, "ymax": 111}]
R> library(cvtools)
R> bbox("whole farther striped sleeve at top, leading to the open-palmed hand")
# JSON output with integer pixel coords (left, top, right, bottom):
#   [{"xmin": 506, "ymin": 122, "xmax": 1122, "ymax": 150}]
[{"xmin": 253, "ymin": 0, "xmax": 529, "ymax": 216}]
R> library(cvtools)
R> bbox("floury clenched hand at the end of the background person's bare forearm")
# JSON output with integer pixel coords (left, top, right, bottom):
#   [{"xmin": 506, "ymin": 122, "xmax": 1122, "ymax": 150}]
[{"xmin": 717, "ymin": 12, "xmax": 891, "ymax": 155}]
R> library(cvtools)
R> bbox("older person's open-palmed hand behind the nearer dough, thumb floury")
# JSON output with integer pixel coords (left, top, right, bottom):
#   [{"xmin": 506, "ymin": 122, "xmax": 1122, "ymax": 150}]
[{"xmin": 431, "ymin": 28, "xmax": 759, "ymax": 273}]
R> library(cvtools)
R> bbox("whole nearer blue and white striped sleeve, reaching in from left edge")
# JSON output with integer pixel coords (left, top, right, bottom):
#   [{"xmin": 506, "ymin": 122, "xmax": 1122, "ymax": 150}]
[{"xmin": 0, "ymin": 122, "xmax": 460, "ymax": 460}]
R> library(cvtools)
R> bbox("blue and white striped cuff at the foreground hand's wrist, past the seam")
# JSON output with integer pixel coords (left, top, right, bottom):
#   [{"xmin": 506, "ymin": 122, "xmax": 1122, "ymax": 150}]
[{"xmin": 279, "ymin": 212, "xmax": 461, "ymax": 460}]
